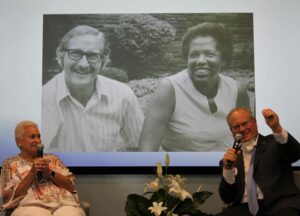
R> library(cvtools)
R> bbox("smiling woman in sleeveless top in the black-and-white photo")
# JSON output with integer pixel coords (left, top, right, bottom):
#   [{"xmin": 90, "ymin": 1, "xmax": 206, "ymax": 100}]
[{"xmin": 140, "ymin": 22, "xmax": 250, "ymax": 152}]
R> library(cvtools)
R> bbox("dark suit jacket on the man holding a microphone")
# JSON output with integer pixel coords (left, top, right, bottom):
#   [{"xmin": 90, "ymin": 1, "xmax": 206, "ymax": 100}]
[{"xmin": 219, "ymin": 134, "xmax": 300, "ymax": 214}]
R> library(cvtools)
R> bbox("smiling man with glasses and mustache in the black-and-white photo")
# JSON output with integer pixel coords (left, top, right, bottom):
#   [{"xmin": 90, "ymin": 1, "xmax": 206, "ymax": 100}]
[{"xmin": 42, "ymin": 26, "xmax": 143, "ymax": 152}]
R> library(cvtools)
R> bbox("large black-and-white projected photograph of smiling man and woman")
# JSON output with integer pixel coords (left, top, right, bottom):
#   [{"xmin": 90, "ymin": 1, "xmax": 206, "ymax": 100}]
[{"xmin": 41, "ymin": 13, "xmax": 255, "ymax": 152}]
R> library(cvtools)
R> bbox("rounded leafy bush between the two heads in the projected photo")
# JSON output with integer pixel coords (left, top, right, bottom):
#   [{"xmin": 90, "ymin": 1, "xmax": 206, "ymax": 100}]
[{"xmin": 105, "ymin": 14, "xmax": 176, "ymax": 77}]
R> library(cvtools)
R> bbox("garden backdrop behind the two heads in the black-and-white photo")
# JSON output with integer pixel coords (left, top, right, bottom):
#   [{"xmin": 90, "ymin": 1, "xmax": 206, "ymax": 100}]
[{"xmin": 42, "ymin": 13, "xmax": 254, "ymax": 84}]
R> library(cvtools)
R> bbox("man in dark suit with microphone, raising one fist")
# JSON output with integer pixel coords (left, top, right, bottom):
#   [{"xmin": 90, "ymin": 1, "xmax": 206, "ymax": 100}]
[{"xmin": 219, "ymin": 108, "xmax": 300, "ymax": 216}]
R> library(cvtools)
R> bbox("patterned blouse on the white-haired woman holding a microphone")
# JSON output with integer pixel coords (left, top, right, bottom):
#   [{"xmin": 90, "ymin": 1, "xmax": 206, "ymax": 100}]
[{"xmin": 0, "ymin": 154, "xmax": 79, "ymax": 210}]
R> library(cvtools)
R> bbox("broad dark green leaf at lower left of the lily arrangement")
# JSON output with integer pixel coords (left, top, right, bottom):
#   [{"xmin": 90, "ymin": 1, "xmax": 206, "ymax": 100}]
[{"xmin": 125, "ymin": 194, "xmax": 152, "ymax": 216}]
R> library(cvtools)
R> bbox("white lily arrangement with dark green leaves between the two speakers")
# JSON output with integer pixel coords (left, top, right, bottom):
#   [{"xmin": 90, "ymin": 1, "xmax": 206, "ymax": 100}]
[{"xmin": 125, "ymin": 154, "xmax": 212, "ymax": 216}]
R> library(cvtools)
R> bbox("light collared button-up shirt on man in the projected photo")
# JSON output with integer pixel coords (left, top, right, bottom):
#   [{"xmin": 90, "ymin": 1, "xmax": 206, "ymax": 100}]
[{"xmin": 42, "ymin": 72, "xmax": 144, "ymax": 152}]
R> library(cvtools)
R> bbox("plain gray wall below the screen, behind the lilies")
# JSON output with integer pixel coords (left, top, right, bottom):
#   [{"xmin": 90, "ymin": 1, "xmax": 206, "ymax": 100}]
[{"xmin": 0, "ymin": 171, "xmax": 300, "ymax": 216}]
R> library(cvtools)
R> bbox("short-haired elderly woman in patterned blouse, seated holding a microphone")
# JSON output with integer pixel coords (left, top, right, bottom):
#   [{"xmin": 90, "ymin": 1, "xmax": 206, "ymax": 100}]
[{"xmin": 1, "ymin": 121, "xmax": 85, "ymax": 216}]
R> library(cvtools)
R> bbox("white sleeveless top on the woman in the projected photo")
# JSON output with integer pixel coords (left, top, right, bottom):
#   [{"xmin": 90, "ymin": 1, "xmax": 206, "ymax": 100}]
[{"xmin": 161, "ymin": 70, "xmax": 238, "ymax": 152}]
